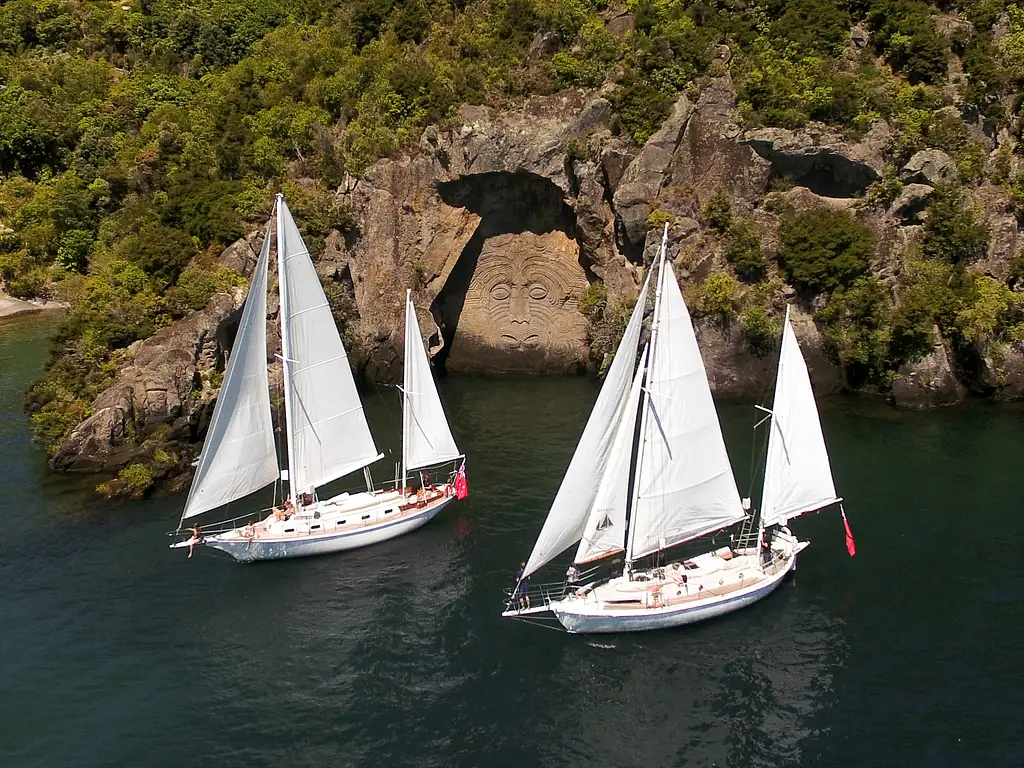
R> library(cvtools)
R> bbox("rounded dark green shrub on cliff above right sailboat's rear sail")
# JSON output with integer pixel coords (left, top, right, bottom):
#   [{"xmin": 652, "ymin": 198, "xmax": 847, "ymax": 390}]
[{"xmin": 779, "ymin": 209, "xmax": 873, "ymax": 295}]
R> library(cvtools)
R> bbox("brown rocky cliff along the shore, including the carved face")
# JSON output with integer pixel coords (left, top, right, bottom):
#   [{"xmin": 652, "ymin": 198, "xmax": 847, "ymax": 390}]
[{"xmin": 53, "ymin": 47, "xmax": 1024, "ymax": 483}]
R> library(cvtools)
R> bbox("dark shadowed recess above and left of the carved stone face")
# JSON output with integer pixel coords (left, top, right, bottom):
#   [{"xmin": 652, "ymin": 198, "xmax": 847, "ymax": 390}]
[{"xmin": 430, "ymin": 172, "xmax": 591, "ymax": 375}]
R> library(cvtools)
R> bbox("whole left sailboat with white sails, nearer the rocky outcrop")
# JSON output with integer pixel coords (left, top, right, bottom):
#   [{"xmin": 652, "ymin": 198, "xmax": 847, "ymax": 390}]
[{"xmin": 171, "ymin": 195, "xmax": 466, "ymax": 562}]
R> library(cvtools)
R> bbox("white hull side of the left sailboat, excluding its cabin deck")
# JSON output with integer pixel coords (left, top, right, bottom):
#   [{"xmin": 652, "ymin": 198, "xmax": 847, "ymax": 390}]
[{"xmin": 194, "ymin": 496, "xmax": 455, "ymax": 563}]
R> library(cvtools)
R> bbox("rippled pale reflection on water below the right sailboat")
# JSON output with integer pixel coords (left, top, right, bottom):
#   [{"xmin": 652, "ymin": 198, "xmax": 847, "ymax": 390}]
[{"xmin": 544, "ymin": 589, "xmax": 845, "ymax": 766}]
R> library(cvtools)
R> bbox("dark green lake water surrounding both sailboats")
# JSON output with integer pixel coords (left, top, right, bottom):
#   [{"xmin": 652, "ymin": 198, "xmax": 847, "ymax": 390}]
[{"xmin": 0, "ymin": 316, "xmax": 1024, "ymax": 768}]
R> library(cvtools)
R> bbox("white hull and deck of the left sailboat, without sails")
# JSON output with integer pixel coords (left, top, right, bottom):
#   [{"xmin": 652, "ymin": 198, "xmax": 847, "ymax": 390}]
[{"xmin": 185, "ymin": 485, "xmax": 455, "ymax": 562}]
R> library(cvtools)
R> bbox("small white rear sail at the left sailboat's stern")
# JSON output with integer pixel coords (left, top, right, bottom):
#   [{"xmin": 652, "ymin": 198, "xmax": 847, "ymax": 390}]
[{"xmin": 402, "ymin": 291, "xmax": 462, "ymax": 469}]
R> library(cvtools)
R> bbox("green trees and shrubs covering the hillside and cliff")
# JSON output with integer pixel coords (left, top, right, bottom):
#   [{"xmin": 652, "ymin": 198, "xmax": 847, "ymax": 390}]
[{"xmin": 6, "ymin": 0, "xmax": 1024, "ymax": 473}]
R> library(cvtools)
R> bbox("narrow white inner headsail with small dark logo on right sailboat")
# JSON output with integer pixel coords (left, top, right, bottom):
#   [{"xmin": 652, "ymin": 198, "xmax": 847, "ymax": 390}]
[{"xmin": 575, "ymin": 349, "xmax": 647, "ymax": 563}]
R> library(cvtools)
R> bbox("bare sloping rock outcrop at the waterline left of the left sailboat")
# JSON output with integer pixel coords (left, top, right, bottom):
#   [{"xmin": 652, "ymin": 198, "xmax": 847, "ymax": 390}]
[{"xmin": 50, "ymin": 290, "xmax": 245, "ymax": 471}]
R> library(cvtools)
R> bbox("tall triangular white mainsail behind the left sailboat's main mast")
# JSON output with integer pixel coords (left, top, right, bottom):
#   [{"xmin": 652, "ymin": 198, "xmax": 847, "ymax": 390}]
[{"xmin": 278, "ymin": 196, "xmax": 382, "ymax": 494}]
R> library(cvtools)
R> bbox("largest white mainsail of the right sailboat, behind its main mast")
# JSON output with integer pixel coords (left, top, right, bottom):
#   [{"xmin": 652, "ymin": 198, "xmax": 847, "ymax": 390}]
[{"xmin": 627, "ymin": 260, "xmax": 745, "ymax": 560}]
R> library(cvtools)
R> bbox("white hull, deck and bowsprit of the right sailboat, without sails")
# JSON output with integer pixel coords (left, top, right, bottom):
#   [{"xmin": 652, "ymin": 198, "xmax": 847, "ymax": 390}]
[{"xmin": 505, "ymin": 535, "xmax": 808, "ymax": 634}]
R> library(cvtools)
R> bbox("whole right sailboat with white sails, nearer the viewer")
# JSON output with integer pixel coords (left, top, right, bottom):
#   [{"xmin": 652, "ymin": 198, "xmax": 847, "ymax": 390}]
[{"xmin": 502, "ymin": 225, "xmax": 845, "ymax": 633}]
